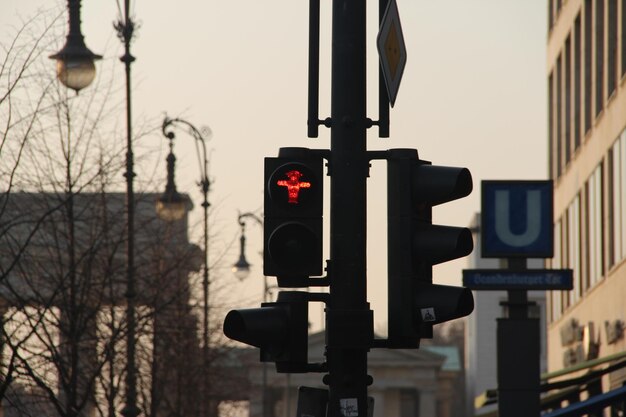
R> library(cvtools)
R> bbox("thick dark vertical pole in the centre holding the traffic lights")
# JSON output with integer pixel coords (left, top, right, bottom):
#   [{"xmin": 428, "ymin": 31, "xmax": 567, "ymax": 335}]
[{"xmin": 324, "ymin": 0, "xmax": 373, "ymax": 417}]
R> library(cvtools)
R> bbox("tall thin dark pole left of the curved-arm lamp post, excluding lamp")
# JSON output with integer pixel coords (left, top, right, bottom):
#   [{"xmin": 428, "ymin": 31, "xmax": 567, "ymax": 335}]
[{"xmin": 115, "ymin": 0, "xmax": 139, "ymax": 417}]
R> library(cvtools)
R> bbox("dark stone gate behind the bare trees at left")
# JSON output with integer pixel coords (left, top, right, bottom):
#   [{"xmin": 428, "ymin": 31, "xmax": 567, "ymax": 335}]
[{"xmin": 0, "ymin": 192, "xmax": 204, "ymax": 417}]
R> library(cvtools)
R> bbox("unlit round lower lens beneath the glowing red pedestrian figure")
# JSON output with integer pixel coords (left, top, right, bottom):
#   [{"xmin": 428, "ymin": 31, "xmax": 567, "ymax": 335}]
[{"xmin": 269, "ymin": 222, "xmax": 317, "ymax": 272}]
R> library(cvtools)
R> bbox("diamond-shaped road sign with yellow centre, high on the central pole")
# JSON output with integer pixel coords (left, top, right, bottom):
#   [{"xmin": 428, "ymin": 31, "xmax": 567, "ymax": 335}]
[{"xmin": 376, "ymin": 0, "xmax": 406, "ymax": 107}]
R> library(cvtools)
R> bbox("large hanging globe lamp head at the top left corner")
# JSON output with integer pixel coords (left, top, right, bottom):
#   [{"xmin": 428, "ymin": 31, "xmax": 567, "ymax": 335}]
[{"xmin": 49, "ymin": 0, "xmax": 102, "ymax": 93}]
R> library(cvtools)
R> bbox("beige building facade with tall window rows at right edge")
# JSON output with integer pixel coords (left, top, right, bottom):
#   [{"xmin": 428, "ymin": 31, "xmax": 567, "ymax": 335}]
[{"xmin": 547, "ymin": 0, "xmax": 626, "ymax": 391}]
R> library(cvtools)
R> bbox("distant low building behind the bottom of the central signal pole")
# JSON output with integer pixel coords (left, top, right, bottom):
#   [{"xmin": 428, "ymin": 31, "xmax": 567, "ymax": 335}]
[{"xmin": 227, "ymin": 333, "xmax": 464, "ymax": 417}]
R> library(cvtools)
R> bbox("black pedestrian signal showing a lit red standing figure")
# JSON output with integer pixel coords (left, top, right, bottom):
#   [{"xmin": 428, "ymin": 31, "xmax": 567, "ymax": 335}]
[{"xmin": 263, "ymin": 148, "xmax": 323, "ymax": 278}]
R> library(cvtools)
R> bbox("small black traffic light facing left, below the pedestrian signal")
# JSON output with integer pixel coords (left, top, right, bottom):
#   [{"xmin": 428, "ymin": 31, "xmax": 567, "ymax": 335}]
[{"xmin": 224, "ymin": 291, "xmax": 309, "ymax": 373}]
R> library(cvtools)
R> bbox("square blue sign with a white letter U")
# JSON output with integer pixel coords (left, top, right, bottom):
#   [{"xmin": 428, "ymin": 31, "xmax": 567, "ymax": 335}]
[{"xmin": 481, "ymin": 180, "xmax": 554, "ymax": 258}]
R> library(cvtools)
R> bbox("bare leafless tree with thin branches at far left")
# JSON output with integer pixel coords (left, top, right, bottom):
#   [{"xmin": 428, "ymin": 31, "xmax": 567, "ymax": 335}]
[{"xmin": 0, "ymin": 6, "xmax": 208, "ymax": 417}]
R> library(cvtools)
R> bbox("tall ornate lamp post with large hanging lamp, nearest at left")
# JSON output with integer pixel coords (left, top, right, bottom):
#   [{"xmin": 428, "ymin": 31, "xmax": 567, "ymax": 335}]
[{"xmin": 50, "ymin": 0, "xmax": 139, "ymax": 417}]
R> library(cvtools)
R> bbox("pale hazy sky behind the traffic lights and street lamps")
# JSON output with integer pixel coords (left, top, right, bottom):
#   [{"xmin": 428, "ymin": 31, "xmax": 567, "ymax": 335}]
[{"xmin": 0, "ymin": 0, "xmax": 547, "ymax": 329}]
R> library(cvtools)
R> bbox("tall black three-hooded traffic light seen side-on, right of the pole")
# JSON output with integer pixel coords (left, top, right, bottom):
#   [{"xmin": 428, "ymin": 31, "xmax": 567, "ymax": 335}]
[{"xmin": 387, "ymin": 149, "xmax": 474, "ymax": 348}]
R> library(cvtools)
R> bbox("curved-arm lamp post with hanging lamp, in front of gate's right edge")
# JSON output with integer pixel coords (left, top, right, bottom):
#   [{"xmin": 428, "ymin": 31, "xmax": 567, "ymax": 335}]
[{"xmin": 157, "ymin": 116, "xmax": 212, "ymax": 417}]
